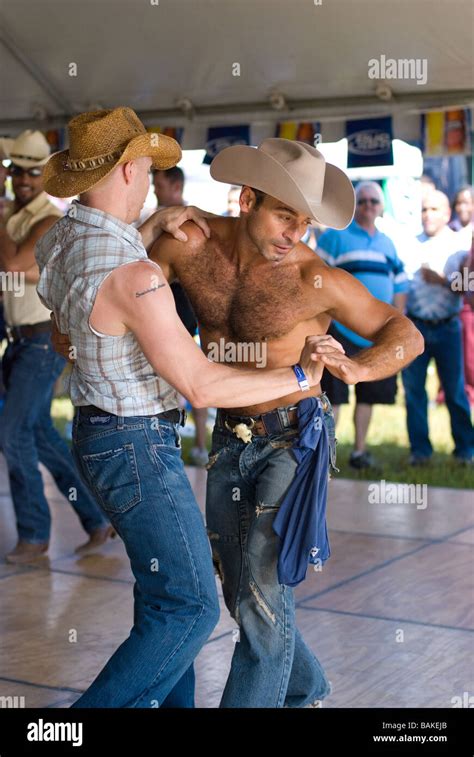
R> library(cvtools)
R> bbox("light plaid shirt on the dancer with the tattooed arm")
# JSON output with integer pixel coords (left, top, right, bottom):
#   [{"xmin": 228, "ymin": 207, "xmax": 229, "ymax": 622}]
[{"xmin": 36, "ymin": 202, "xmax": 178, "ymax": 417}]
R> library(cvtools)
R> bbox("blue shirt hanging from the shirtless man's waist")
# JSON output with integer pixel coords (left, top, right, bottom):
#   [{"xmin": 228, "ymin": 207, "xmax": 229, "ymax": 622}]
[{"xmin": 273, "ymin": 397, "xmax": 331, "ymax": 586}]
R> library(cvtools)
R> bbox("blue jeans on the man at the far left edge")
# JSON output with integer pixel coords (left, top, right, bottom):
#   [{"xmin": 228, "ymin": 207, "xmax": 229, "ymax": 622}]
[{"xmin": 0, "ymin": 333, "xmax": 106, "ymax": 544}]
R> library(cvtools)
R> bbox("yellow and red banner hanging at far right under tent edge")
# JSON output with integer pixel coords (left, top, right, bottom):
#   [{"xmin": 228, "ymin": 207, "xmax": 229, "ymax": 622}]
[{"xmin": 423, "ymin": 110, "xmax": 471, "ymax": 158}]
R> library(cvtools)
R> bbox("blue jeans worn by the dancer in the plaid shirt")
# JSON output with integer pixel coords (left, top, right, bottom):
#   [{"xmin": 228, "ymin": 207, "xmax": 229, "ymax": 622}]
[{"xmin": 73, "ymin": 411, "xmax": 219, "ymax": 708}]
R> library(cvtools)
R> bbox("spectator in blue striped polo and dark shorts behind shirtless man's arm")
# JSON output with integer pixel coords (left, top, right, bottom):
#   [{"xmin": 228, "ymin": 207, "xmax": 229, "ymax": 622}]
[{"xmin": 317, "ymin": 181, "xmax": 408, "ymax": 469}]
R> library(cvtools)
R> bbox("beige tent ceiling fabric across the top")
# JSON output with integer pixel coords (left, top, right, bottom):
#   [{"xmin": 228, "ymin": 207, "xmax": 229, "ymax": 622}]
[{"xmin": 0, "ymin": 0, "xmax": 474, "ymax": 134}]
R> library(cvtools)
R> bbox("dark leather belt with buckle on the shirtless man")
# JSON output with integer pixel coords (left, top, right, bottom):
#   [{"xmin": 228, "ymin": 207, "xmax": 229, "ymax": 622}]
[{"xmin": 216, "ymin": 394, "xmax": 329, "ymax": 441}]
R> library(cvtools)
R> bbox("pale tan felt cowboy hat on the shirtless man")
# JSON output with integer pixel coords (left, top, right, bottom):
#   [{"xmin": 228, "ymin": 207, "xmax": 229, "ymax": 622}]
[{"xmin": 211, "ymin": 137, "xmax": 355, "ymax": 229}]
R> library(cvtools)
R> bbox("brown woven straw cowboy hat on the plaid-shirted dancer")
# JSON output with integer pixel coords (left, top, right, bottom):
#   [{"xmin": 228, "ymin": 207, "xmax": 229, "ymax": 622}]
[{"xmin": 43, "ymin": 107, "xmax": 181, "ymax": 197}]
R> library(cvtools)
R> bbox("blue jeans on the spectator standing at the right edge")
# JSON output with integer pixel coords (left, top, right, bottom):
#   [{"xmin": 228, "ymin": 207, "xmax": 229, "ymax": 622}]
[{"xmin": 402, "ymin": 318, "xmax": 474, "ymax": 459}]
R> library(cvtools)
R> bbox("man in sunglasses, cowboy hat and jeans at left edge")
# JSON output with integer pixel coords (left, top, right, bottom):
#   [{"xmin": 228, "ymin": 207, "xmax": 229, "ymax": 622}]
[{"xmin": 0, "ymin": 130, "xmax": 113, "ymax": 564}]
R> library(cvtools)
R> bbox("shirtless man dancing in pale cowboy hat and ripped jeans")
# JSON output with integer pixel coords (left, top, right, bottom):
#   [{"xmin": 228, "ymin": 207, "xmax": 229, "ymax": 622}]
[{"xmin": 150, "ymin": 139, "xmax": 423, "ymax": 707}]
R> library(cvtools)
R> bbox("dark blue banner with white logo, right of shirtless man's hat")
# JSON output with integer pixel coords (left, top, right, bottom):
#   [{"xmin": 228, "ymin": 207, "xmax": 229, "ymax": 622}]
[{"xmin": 346, "ymin": 116, "xmax": 393, "ymax": 168}]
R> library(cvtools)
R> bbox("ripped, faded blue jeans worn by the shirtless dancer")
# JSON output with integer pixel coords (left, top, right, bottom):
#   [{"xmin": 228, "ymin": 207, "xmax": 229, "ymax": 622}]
[{"xmin": 207, "ymin": 398, "xmax": 336, "ymax": 707}]
